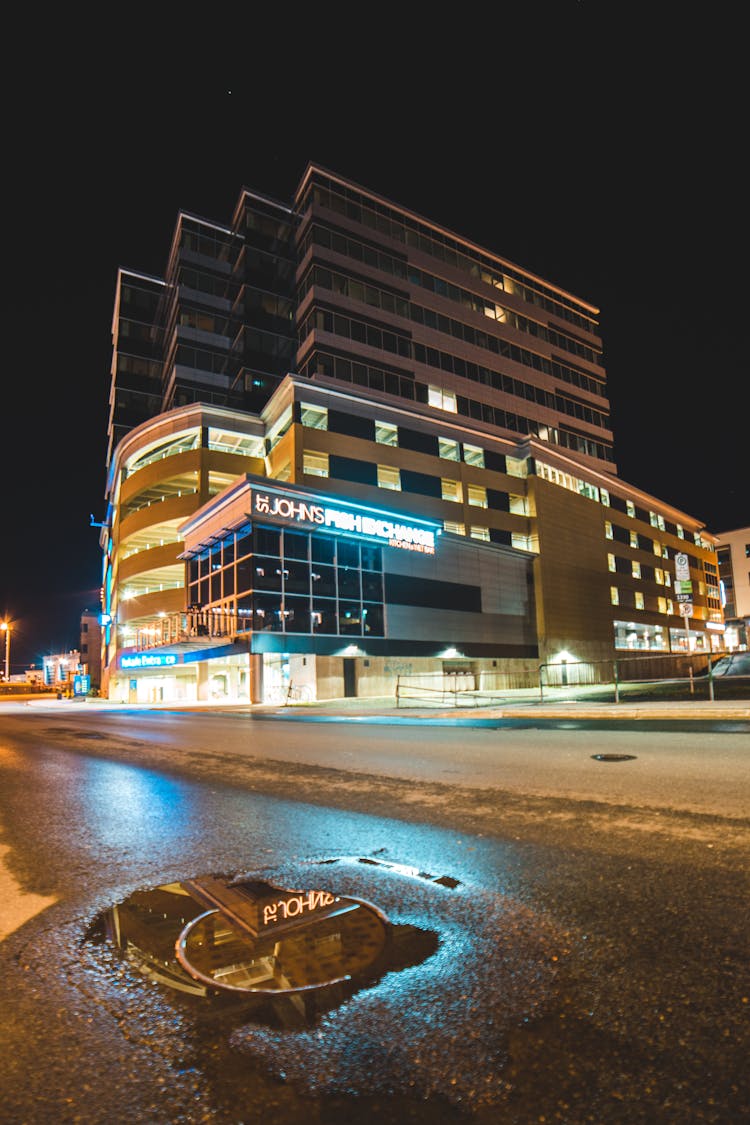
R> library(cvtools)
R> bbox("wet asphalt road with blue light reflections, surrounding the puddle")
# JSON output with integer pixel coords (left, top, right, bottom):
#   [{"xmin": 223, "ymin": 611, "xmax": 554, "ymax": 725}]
[{"xmin": 0, "ymin": 703, "xmax": 750, "ymax": 1125}]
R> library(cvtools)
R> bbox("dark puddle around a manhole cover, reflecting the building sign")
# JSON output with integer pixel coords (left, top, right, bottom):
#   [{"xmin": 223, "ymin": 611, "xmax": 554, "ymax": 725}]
[{"xmin": 89, "ymin": 876, "xmax": 437, "ymax": 1027}]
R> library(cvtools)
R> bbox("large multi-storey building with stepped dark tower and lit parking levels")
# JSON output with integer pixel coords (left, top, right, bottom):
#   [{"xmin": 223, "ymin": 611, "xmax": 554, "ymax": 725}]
[{"xmin": 96, "ymin": 164, "xmax": 723, "ymax": 700}]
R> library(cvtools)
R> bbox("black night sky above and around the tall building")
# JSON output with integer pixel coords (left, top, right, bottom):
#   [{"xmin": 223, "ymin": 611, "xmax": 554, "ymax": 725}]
[{"xmin": 0, "ymin": 0, "xmax": 750, "ymax": 672}]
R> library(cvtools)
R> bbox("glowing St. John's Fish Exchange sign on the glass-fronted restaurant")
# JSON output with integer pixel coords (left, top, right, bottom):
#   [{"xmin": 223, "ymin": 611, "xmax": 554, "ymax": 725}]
[{"xmin": 252, "ymin": 489, "xmax": 436, "ymax": 555}]
